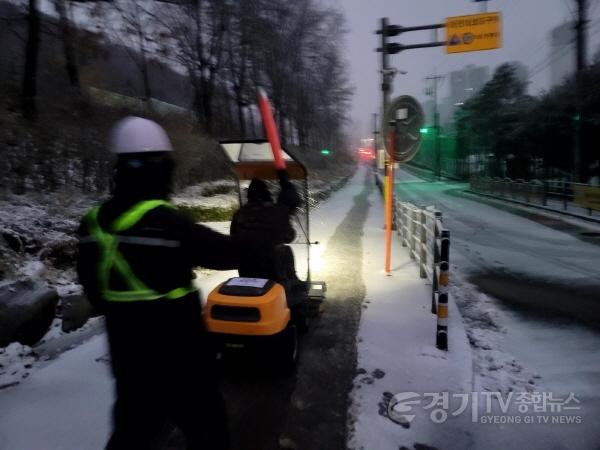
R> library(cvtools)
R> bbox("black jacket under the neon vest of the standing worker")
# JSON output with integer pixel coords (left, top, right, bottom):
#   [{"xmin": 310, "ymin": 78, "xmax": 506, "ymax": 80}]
[{"xmin": 77, "ymin": 198, "xmax": 244, "ymax": 377}]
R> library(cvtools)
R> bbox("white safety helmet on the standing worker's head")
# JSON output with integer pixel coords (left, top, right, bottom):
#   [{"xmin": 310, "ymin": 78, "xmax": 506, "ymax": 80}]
[{"xmin": 110, "ymin": 116, "xmax": 173, "ymax": 154}]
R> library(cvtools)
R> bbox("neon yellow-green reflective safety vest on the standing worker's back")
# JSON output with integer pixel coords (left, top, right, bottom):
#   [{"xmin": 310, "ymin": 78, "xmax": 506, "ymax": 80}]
[{"xmin": 85, "ymin": 200, "xmax": 197, "ymax": 302}]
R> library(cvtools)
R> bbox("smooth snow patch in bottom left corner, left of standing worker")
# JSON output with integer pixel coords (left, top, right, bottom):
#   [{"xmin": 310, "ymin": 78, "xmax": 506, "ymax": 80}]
[{"xmin": 0, "ymin": 336, "xmax": 113, "ymax": 450}]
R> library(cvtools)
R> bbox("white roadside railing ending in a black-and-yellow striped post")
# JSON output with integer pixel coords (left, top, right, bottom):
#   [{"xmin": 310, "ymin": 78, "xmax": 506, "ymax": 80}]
[{"xmin": 394, "ymin": 201, "xmax": 450, "ymax": 350}]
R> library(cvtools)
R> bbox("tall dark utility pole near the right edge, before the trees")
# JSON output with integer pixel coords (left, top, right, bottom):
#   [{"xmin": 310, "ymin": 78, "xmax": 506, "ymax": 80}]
[{"xmin": 573, "ymin": 0, "xmax": 587, "ymax": 182}]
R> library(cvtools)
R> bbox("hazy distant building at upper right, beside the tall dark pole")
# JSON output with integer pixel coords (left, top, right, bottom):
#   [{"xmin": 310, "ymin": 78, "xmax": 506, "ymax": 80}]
[{"xmin": 549, "ymin": 22, "xmax": 575, "ymax": 86}]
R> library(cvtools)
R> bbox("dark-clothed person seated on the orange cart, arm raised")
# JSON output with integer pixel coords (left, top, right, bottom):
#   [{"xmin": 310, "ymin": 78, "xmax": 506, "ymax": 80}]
[{"xmin": 230, "ymin": 172, "xmax": 301, "ymax": 290}]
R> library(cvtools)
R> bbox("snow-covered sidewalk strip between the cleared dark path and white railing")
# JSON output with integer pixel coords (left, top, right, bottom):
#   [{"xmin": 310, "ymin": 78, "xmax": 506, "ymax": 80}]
[{"xmin": 349, "ymin": 173, "xmax": 473, "ymax": 450}]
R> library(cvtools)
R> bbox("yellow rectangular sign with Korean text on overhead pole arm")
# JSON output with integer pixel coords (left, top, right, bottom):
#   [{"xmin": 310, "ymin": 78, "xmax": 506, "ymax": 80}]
[{"xmin": 446, "ymin": 12, "xmax": 502, "ymax": 53}]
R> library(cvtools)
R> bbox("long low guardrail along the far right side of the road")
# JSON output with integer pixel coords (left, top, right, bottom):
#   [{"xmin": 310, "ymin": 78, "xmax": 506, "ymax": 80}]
[{"xmin": 471, "ymin": 177, "xmax": 600, "ymax": 218}]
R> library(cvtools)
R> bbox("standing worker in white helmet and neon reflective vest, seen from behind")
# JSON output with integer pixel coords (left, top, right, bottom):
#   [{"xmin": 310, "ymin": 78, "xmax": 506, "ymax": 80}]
[{"xmin": 77, "ymin": 117, "xmax": 244, "ymax": 450}]
